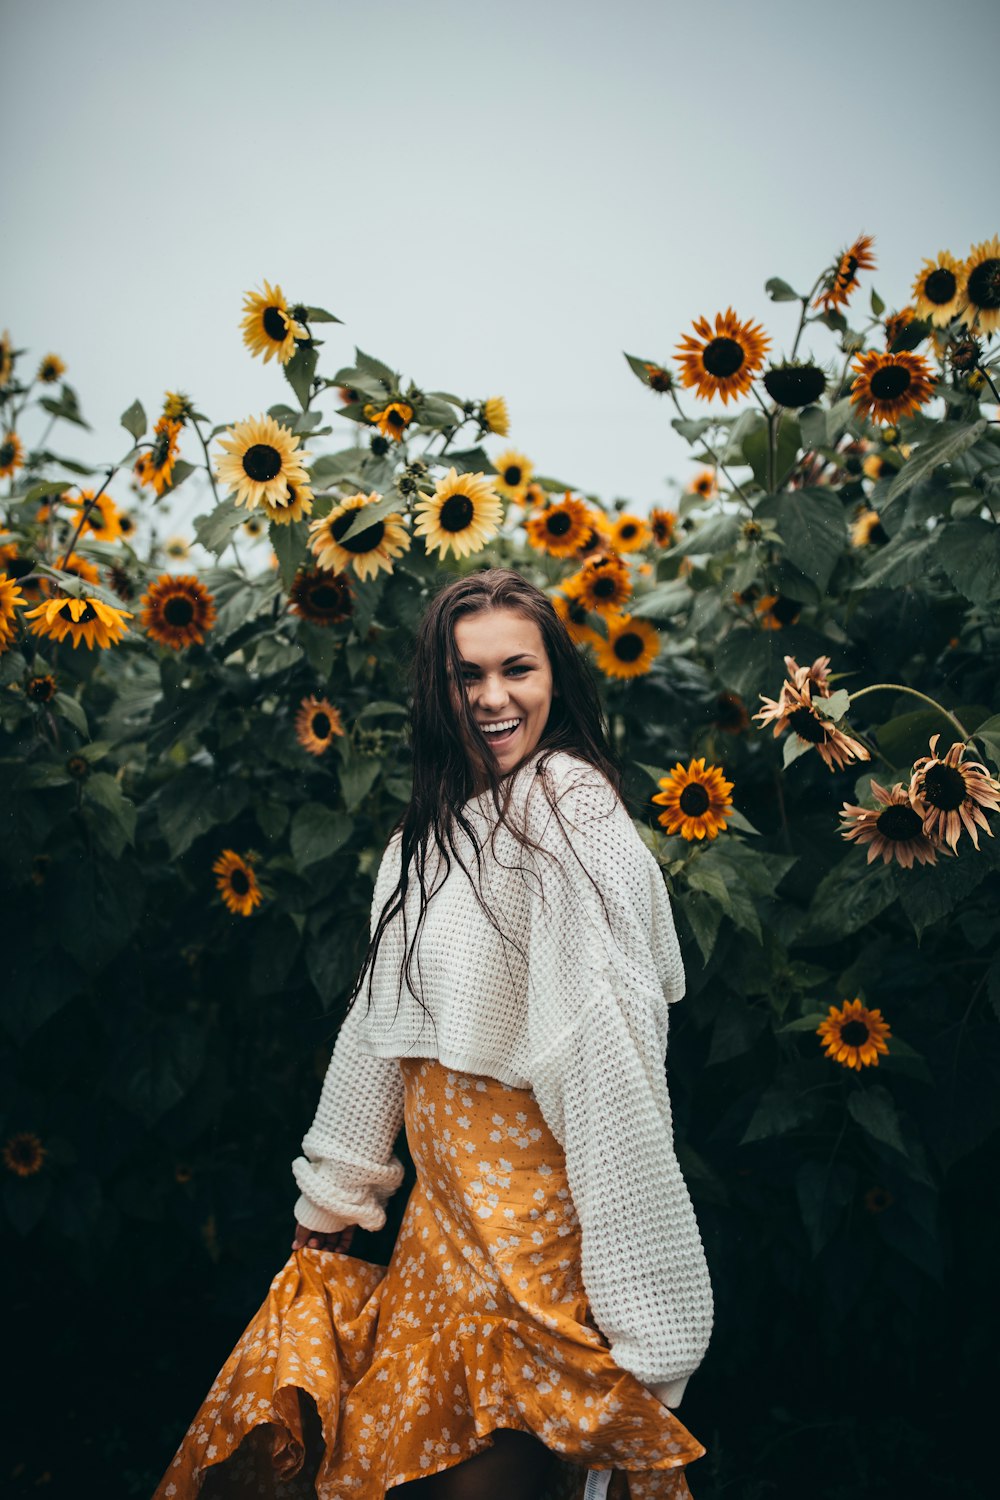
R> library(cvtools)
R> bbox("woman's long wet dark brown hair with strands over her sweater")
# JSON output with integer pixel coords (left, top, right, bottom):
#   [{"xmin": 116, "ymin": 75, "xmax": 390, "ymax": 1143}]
[{"xmin": 348, "ymin": 567, "xmax": 622, "ymax": 1020}]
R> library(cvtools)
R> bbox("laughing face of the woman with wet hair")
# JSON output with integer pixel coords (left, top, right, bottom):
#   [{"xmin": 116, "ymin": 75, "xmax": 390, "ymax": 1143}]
[{"xmin": 454, "ymin": 609, "xmax": 553, "ymax": 776}]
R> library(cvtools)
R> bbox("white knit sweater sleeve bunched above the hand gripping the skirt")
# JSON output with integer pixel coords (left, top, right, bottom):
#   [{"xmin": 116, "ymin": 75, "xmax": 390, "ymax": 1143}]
[{"xmin": 292, "ymin": 851, "xmax": 403, "ymax": 1235}]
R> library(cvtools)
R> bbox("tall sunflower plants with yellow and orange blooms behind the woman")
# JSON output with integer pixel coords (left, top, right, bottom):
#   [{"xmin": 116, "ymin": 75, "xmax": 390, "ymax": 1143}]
[{"xmin": 0, "ymin": 236, "xmax": 1000, "ymax": 1500}]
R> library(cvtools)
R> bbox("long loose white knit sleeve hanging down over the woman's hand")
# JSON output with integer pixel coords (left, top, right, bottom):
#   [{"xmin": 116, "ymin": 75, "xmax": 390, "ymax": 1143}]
[{"xmin": 528, "ymin": 762, "xmax": 714, "ymax": 1406}]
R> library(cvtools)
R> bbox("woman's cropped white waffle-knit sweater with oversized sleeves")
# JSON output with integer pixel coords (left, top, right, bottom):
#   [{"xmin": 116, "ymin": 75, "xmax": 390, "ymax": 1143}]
[{"xmin": 292, "ymin": 752, "xmax": 712, "ymax": 1406}]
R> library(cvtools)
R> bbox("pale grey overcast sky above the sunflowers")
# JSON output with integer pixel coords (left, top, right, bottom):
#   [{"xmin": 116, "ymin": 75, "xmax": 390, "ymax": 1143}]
[{"xmin": 0, "ymin": 0, "xmax": 1000, "ymax": 534}]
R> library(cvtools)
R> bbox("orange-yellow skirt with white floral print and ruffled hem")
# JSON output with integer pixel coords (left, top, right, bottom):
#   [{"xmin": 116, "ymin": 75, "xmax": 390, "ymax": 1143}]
[{"xmin": 153, "ymin": 1058, "xmax": 705, "ymax": 1500}]
